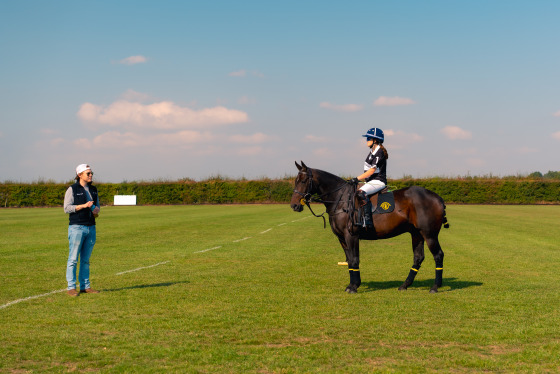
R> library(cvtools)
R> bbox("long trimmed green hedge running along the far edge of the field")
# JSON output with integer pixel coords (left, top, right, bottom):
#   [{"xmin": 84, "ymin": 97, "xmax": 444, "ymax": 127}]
[{"xmin": 0, "ymin": 178, "xmax": 560, "ymax": 207}]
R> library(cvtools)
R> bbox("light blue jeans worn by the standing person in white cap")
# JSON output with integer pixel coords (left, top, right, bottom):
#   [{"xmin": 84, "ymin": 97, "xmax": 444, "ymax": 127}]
[{"xmin": 66, "ymin": 225, "xmax": 96, "ymax": 290}]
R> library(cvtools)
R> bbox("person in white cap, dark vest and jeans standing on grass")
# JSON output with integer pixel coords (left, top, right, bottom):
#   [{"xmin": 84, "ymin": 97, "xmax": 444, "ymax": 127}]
[{"xmin": 64, "ymin": 164, "xmax": 100, "ymax": 296}]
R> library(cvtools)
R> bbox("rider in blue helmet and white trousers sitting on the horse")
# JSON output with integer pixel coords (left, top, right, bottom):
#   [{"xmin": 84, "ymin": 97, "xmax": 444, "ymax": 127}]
[{"xmin": 352, "ymin": 127, "xmax": 389, "ymax": 227}]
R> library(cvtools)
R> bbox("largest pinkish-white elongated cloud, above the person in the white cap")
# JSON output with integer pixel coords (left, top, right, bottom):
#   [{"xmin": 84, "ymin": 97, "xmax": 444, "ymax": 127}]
[{"xmin": 77, "ymin": 100, "xmax": 249, "ymax": 129}]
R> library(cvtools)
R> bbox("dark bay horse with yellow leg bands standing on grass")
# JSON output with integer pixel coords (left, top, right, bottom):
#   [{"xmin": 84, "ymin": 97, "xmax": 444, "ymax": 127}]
[{"xmin": 290, "ymin": 161, "xmax": 449, "ymax": 293}]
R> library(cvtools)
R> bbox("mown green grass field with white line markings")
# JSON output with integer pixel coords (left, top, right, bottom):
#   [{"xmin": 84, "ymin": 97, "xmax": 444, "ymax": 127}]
[{"xmin": 0, "ymin": 205, "xmax": 560, "ymax": 373}]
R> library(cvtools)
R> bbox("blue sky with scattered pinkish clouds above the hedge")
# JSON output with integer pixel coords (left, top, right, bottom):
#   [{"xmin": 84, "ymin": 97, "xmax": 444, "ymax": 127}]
[{"xmin": 0, "ymin": 0, "xmax": 560, "ymax": 183}]
